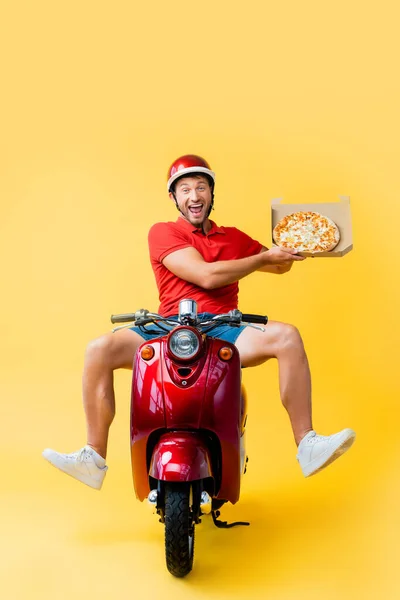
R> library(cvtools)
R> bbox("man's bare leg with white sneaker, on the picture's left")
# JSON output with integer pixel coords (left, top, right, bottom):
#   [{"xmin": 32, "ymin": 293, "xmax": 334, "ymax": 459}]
[{"xmin": 43, "ymin": 329, "xmax": 144, "ymax": 490}]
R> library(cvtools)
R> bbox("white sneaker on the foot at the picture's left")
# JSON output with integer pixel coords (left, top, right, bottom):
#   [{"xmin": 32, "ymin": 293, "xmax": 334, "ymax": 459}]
[{"xmin": 42, "ymin": 446, "xmax": 108, "ymax": 490}]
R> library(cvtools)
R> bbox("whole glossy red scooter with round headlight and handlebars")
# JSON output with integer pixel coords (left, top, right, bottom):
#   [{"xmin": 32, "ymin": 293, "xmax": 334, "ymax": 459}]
[{"xmin": 111, "ymin": 300, "xmax": 268, "ymax": 577}]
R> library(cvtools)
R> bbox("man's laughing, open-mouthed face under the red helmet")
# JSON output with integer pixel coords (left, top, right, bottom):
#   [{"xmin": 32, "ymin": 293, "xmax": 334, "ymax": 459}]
[{"xmin": 169, "ymin": 175, "xmax": 212, "ymax": 227}]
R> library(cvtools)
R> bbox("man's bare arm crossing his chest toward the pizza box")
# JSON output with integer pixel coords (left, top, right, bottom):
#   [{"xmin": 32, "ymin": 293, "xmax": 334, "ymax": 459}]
[{"xmin": 162, "ymin": 247, "xmax": 304, "ymax": 290}]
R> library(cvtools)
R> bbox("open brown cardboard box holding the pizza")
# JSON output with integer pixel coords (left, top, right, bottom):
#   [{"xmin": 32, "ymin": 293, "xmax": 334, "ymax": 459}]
[{"xmin": 271, "ymin": 196, "xmax": 353, "ymax": 258}]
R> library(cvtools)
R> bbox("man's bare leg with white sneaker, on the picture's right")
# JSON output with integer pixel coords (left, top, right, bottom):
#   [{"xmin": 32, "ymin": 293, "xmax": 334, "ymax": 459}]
[{"xmin": 236, "ymin": 321, "xmax": 355, "ymax": 477}]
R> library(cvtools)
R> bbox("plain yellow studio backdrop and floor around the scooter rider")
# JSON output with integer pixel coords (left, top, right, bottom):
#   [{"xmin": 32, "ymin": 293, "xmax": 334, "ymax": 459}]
[{"xmin": 0, "ymin": 0, "xmax": 400, "ymax": 600}]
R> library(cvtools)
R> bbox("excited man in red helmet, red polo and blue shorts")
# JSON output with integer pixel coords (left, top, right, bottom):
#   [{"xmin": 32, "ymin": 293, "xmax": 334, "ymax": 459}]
[{"xmin": 43, "ymin": 155, "xmax": 355, "ymax": 489}]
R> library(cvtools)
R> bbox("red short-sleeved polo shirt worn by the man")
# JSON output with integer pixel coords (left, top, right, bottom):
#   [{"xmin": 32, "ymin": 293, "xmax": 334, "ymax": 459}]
[{"xmin": 149, "ymin": 217, "xmax": 262, "ymax": 316}]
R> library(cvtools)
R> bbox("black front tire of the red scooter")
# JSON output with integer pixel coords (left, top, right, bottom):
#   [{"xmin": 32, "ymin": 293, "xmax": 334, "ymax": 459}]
[{"xmin": 164, "ymin": 483, "xmax": 194, "ymax": 577}]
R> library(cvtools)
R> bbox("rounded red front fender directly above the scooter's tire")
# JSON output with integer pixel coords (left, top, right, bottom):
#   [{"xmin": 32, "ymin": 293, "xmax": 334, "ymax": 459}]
[{"xmin": 149, "ymin": 431, "xmax": 212, "ymax": 481}]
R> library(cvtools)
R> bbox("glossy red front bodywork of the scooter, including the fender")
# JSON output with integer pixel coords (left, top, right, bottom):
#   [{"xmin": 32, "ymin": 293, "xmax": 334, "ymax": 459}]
[{"xmin": 131, "ymin": 337, "xmax": 241, "ymax": 503}]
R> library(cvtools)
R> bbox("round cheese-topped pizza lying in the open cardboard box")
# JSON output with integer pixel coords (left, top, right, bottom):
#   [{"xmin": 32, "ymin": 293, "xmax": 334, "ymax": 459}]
[{"xmin": 272, "ymin": 211, "xmax": 340, "ymax": 252}]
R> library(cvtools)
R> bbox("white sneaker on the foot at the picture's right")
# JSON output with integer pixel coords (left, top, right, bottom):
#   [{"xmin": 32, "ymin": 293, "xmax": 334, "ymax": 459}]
[{"xmin": 296, "ymin": 428, "xmax": 356, "ymax": 477}]
